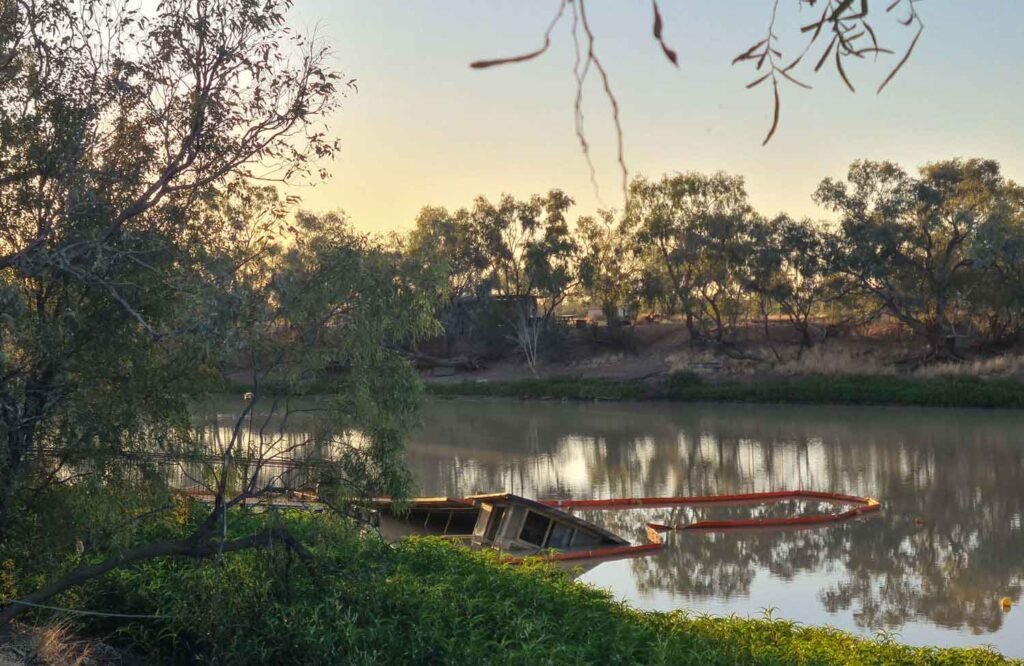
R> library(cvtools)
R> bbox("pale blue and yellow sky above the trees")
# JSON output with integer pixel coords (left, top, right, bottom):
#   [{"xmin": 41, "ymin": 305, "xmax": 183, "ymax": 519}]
[{"xmin": 282, "ymin": 0, "xmax": 1024, "ymax": 232}]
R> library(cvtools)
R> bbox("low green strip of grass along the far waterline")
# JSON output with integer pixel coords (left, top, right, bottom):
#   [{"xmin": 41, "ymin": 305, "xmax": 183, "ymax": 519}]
[{"xmin": 427, "ymin": 373, "xmax": 1024, "ymax": 408}]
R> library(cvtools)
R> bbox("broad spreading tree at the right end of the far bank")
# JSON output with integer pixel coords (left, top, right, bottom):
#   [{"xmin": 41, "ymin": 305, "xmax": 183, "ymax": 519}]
[{"xmin": 815, "ymin": 159, "xmax": 1019, "ymax": 359}]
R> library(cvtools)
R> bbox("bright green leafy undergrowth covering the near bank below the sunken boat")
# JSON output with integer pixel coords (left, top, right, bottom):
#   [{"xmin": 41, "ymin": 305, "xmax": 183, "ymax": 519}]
[{"xmin": 9, "ymin": 512, "xmax": 1007, "ymax": 664}]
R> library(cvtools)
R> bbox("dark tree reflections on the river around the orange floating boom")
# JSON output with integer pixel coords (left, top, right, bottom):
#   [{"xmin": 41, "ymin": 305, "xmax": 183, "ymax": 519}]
[{"xmin": 410, "ymin": 401, "xmax": 1024, "ymax": 632}]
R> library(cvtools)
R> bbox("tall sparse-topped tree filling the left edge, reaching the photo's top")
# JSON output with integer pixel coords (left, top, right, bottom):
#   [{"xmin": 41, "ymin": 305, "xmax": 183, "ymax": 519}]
[{"xmin": 0, "ymin": 0, "xmax": 345, "ymax": 531}]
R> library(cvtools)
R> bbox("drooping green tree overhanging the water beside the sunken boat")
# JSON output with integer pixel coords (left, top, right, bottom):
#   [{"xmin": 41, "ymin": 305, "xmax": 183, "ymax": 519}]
[{"xmin": 0, "ymin": 186, "xmax": 441, "ymax": 624}]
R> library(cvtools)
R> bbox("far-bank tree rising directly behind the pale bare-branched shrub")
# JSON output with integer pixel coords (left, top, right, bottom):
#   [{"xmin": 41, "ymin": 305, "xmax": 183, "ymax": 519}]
[{"xmin": 471, "ymin": 190, "xmax": 579, "ymax": 373}]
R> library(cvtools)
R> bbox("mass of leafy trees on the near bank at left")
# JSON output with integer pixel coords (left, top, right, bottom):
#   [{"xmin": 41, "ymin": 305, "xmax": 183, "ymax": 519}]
[{"xmin": 0, "ymin": 0, "xmax": 440, "ymax": 625}]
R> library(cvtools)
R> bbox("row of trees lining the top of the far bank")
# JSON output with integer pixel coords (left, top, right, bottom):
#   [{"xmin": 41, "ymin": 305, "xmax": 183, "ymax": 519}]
[{"xmin": 407, "ymin": 159, "xmax": 1024, "ymax": 367}]
